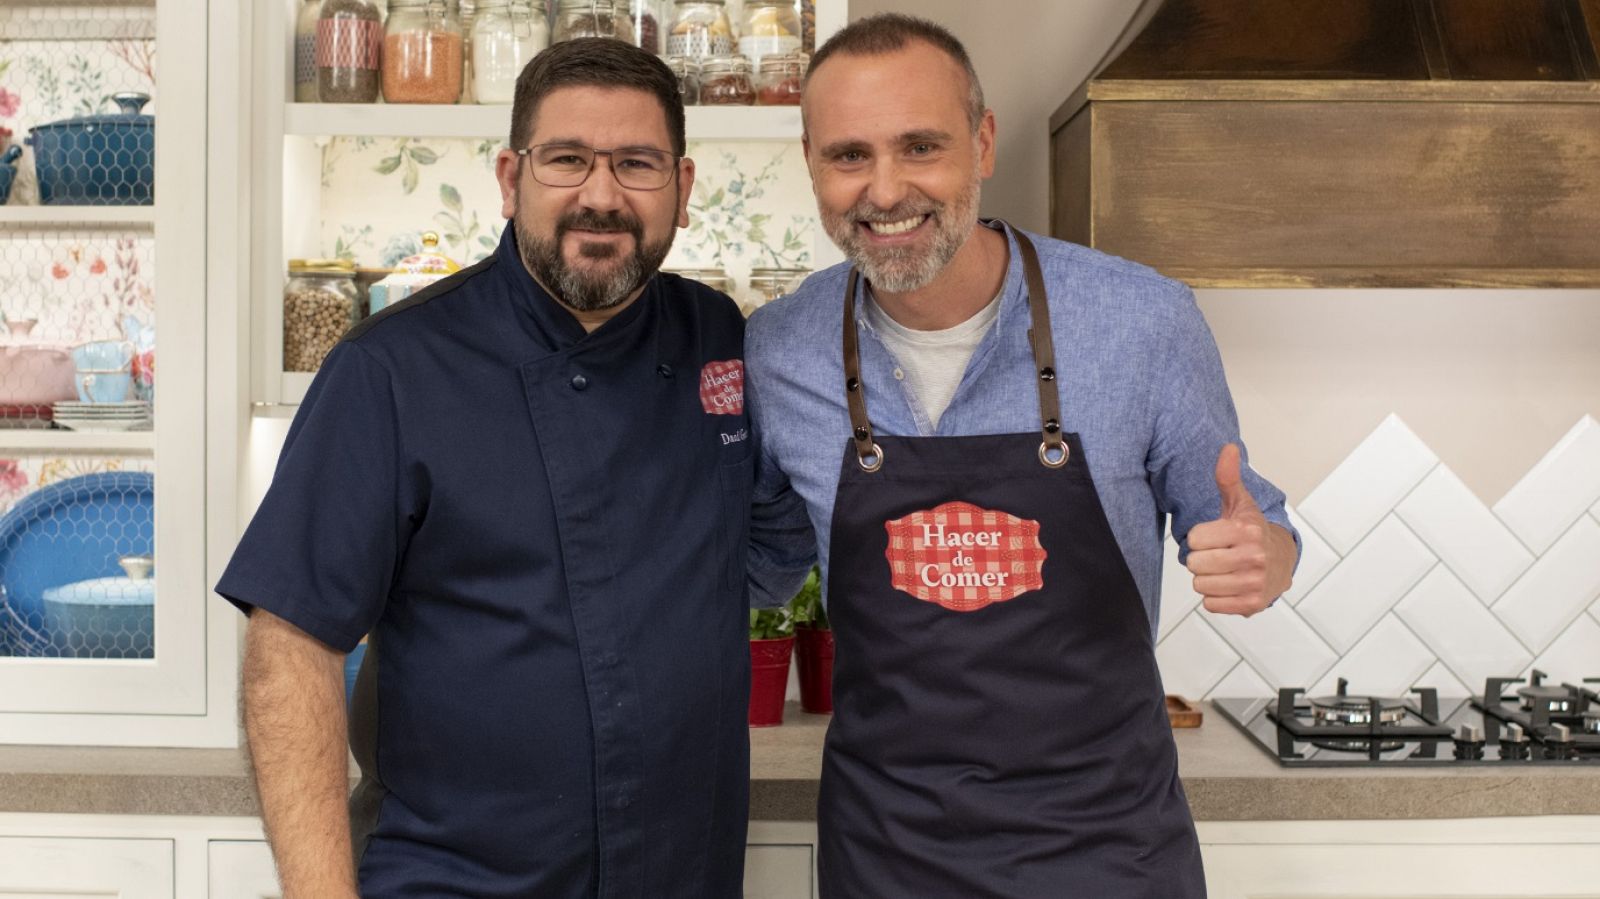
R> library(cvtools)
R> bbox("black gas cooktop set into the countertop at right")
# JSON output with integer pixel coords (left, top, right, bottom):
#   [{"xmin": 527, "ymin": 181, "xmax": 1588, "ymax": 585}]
[{"xmin": 1211, "ymin": 670, "xmax": 1600, "ymax": 768}]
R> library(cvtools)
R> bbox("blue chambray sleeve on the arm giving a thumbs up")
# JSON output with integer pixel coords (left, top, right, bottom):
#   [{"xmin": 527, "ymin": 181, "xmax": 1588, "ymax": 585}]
[{"xmin": 1146, "ymin": 288, "xmax": 1299, "ymax": 565}]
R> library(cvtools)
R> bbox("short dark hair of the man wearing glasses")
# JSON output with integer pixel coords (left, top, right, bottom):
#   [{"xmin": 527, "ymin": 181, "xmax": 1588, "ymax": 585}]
[{"xmin": 510, "ymin": 37, "xmax": 688, "ymax": 157}]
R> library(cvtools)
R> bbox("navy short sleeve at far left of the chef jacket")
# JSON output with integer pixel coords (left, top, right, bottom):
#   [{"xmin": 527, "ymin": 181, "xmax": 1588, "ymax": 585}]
[{"xmin": 216, "ymin": 341, "xmax": 410, "ymax": 653}]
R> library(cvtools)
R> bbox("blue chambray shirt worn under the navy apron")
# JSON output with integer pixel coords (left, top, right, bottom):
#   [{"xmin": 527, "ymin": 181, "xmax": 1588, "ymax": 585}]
[{"xmin": 744, "ymin": 222, "xmax": 1299, "ymax": 635}]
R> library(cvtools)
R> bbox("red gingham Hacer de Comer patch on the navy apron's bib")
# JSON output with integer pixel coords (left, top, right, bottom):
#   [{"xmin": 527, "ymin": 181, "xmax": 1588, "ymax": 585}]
[{"xmin": 883, "ymin": 502, "xmax": 1046, "ymax": 611}]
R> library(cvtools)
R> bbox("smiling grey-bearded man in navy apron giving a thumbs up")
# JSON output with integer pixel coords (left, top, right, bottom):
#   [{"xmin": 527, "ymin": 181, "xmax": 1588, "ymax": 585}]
[{"xmin": 746, "ymin": 14, "xmax": 1296, "ymax": 899}]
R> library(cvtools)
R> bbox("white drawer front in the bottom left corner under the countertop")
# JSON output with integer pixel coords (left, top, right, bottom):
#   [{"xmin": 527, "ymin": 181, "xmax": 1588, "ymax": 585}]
[{"xmin": 0, "ymin": 837, "xmax": 174, "ymax": 899}]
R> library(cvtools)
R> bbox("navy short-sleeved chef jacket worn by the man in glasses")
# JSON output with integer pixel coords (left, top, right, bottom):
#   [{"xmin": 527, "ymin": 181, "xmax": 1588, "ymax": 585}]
[{"xmin": 216, "ymin": 222, "xmax": 754, "ymax": 899}]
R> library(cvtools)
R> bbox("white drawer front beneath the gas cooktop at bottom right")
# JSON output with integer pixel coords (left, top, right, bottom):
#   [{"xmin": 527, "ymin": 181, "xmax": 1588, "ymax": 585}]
[{"xmin": 1198, "ymin": 817, "xmax": 1600, "ymax": 899}]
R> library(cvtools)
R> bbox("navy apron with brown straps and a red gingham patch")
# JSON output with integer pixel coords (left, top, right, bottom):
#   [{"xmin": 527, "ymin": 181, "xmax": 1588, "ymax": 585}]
[{"xmin": 818, "ymin": 230, "xmax": 1205, "ymax": 899}]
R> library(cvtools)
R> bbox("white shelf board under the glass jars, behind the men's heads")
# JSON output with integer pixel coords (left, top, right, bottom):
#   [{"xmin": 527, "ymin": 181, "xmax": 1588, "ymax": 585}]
[{"xmin": 283, "ymin": 102, "xmax": 800, "ymax": 141}]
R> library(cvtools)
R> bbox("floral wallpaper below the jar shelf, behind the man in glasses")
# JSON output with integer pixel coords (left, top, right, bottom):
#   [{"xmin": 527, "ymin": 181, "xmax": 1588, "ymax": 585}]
[{"xmin": 320, "ymin": 138, "xmax": 816, "ymax": 303}]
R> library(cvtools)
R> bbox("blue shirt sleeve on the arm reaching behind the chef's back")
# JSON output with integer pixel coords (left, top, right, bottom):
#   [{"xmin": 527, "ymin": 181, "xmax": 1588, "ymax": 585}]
[{"xmin": 744, "ymin": 347, "xmax": 816, "ymax": 608}]
